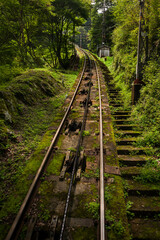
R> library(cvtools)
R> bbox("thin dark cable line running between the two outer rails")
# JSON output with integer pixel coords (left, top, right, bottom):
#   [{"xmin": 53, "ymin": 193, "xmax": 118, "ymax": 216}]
[{"xmin": 60, "ymin": 50, "xmax": 91, "ymax": 240}]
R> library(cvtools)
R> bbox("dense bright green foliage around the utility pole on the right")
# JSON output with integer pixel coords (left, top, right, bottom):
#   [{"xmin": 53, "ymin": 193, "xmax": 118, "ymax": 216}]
[{"xmin": 107, "ymin": 0, "xmax": 160, "ymax": 147}]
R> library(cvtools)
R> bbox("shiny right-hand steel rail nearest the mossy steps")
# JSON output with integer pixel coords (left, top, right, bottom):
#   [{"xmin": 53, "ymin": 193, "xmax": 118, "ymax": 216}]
[{"xmin": 95, "ymin": 62, "xmax": 105, "ymax": 240}]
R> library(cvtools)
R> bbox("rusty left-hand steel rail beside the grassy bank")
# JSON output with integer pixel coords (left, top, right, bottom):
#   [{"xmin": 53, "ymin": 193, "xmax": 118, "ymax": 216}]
[{"xmin": 5, "ymin": 55, "xmax": 86, "ymax": 240}]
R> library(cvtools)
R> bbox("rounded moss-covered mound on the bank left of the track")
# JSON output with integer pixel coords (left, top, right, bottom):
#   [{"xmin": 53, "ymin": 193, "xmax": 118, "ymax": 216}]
[{"xmin": 0, "ymin": 70, "xmax": 62, "ymax": 123}]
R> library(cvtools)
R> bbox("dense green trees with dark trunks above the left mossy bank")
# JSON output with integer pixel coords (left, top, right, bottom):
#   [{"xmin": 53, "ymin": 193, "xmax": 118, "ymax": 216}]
[{"xmin": 0, "ymin": 0, "xmax": 88, "ymax": 68}]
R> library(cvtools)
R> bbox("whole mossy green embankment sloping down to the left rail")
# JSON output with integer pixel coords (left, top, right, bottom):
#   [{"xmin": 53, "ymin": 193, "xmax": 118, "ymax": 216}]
[{"xmin": 0, "ymin": 65, "xmax": 78, "ymax": 237}]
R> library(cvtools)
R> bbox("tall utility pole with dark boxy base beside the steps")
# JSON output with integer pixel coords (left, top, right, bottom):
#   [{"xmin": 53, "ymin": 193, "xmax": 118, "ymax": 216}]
[{"xmin": 132, "ymin": 0, "xmax": 145, "ymax": 105}]
